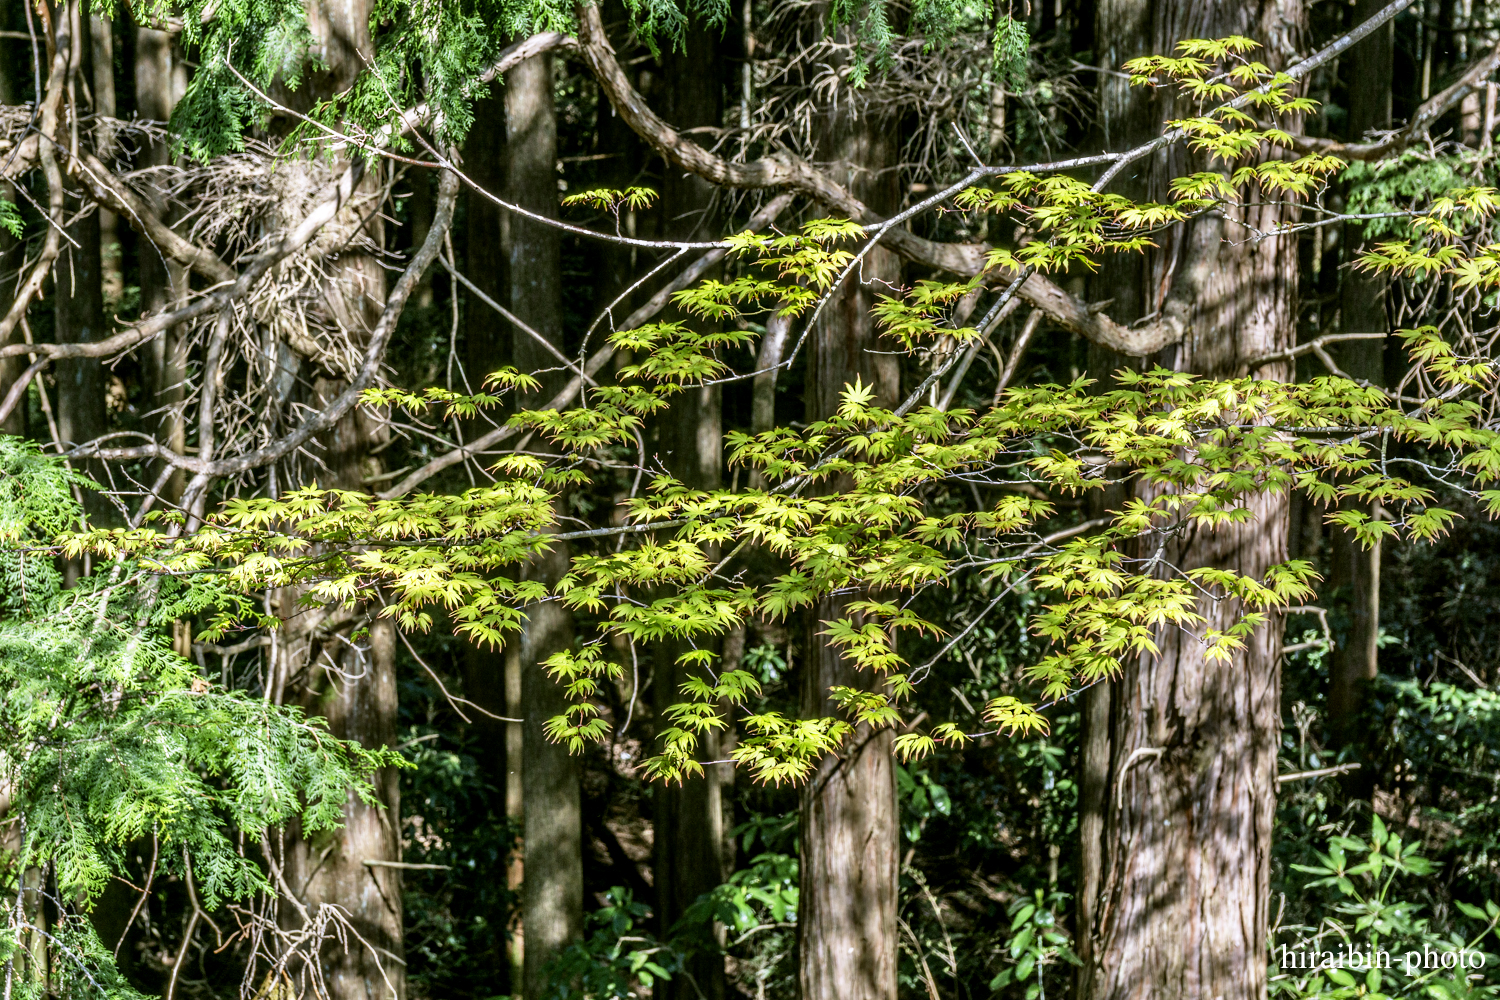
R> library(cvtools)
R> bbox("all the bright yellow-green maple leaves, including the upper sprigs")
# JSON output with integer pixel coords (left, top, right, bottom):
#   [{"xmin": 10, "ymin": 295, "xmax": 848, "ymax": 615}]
[{"xmin": 46, "ymin": 39, "xmax": 1500, "ymax": 783}]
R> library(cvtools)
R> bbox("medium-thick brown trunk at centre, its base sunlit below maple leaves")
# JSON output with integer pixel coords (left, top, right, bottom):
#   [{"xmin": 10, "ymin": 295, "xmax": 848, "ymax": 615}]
[{"xmin": 797, "ymin": 60, "xmax": 900, "ymax": 1000}]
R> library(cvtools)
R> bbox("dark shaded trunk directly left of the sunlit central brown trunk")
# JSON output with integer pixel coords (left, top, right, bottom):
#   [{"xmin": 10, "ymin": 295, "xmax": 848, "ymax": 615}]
[{"xmin": 653, "ymin": 15, "xmax": 729, "ymax": 1000}]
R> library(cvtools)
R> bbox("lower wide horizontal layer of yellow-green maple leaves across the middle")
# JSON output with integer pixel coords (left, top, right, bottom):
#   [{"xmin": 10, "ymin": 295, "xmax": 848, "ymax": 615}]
[{"xmin": 77, "ymin": 358, "xmax": 1500, "ymax": 781}]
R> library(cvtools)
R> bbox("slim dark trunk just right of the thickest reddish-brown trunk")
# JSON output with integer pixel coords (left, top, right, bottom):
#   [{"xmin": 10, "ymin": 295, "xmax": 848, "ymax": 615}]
[{"xmin": 1328, "ymin": 0, "xmax": 1395, "ymax": 744}]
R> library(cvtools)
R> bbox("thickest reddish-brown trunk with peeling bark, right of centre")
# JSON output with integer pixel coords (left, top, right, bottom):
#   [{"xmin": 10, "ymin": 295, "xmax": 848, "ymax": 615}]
[{"xmin": 1080, "ymin": 0, "xmax": 1305, "ymax": 1000}]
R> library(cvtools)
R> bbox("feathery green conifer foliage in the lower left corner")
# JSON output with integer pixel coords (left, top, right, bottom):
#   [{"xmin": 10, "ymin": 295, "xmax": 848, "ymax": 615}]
[{"xmin": 0, "ymin": 438, "xmax": 399, "ymax": 996}]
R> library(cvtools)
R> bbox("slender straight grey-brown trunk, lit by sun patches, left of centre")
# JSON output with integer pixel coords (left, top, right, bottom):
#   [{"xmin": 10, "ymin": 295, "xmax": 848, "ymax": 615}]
[{"xmin": 506, "ymin": 48, "xmax": 584, "ymax": 1000}]
